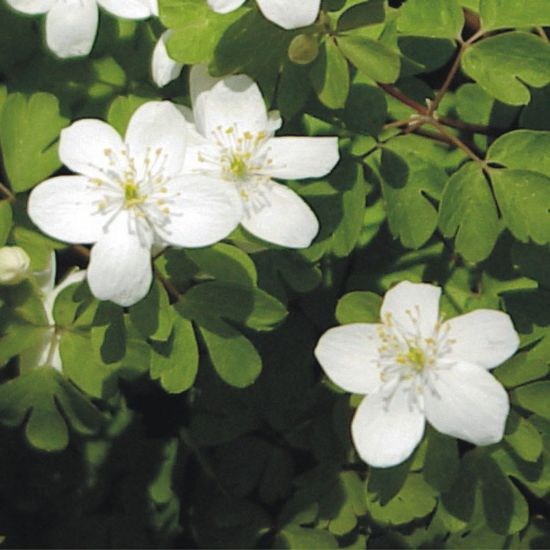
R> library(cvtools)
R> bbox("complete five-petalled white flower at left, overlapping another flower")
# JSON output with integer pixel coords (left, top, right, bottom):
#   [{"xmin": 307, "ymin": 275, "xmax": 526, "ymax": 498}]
[{"xmin": 28, "ymin": 101, "xmax": 242, "ymax": 306}]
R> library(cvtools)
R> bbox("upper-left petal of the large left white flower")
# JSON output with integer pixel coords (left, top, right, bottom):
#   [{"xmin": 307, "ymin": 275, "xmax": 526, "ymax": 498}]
[{"xmin": 59, "ymin": 119, "xmax": 126, "ymax": 178}]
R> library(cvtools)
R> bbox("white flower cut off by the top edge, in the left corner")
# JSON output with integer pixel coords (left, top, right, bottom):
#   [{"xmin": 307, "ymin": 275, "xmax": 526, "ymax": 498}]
[{"xmin": 7, "ymin": 0, "xmax": 158, "ymax": 58}]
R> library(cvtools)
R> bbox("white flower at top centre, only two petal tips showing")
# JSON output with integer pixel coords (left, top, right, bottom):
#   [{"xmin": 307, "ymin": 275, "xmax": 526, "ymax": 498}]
[{"xmin": 208, "ymin": 0, "xmax": 321, "ymax": 29}]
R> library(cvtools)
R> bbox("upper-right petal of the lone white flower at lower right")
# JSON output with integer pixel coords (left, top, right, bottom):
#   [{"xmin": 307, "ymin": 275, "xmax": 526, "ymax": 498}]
[{"xmin": 442, "ymin": 309, "xmax": 519, "ymax": 369}]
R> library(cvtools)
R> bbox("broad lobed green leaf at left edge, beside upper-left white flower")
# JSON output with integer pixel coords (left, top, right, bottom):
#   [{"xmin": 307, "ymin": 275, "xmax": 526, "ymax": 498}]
[{"xmin": 0, "ymin": 92, "xmax": 69, "ymax": 193}]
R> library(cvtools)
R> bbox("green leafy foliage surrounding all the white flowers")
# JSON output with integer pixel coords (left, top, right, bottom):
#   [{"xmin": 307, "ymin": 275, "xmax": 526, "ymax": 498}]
[{"xmin": 0, "ymin": 0, "xmax": 550, "ymax": 549}]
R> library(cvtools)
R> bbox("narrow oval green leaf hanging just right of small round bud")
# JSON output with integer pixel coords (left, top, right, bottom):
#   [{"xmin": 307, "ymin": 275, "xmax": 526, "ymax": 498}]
[{"xmin": 309, "ymin": 39, "xmax": 350, "ymax": 109}]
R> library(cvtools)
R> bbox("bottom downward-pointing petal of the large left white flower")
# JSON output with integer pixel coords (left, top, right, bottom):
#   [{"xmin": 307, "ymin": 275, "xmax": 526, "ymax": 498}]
[{"xmin": 88, "ymin": 210, "xmax": 153, "ymax": 306}]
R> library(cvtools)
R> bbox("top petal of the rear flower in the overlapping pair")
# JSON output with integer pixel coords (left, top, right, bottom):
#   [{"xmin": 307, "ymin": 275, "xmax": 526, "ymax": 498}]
[{"xmin": 191, "ymin": 65, "xmax": 268, "ymax": 138}]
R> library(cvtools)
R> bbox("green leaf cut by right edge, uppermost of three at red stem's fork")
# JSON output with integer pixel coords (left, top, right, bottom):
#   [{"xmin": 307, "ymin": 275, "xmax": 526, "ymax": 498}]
[{"xmin": 487, "ymin": 130, "xmax": 550, "ymax": 175}]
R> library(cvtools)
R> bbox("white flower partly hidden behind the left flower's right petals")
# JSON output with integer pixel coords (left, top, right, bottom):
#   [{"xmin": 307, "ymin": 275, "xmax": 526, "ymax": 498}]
[{"xmin": 184, "ymin": 66, "xmax": 339, "ymax": 248}]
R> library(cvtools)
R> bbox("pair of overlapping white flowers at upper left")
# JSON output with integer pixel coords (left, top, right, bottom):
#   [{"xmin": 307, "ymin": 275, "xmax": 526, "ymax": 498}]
[{"xmin": 28, "ymin": 67, "xmax": 338, "ymax": 306}]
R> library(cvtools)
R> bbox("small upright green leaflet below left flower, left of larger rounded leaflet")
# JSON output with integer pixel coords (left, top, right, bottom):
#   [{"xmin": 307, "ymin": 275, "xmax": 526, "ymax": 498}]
[{"xmin": 151, "ymin": 316, "xmax": 199, "ymax": 393}]
